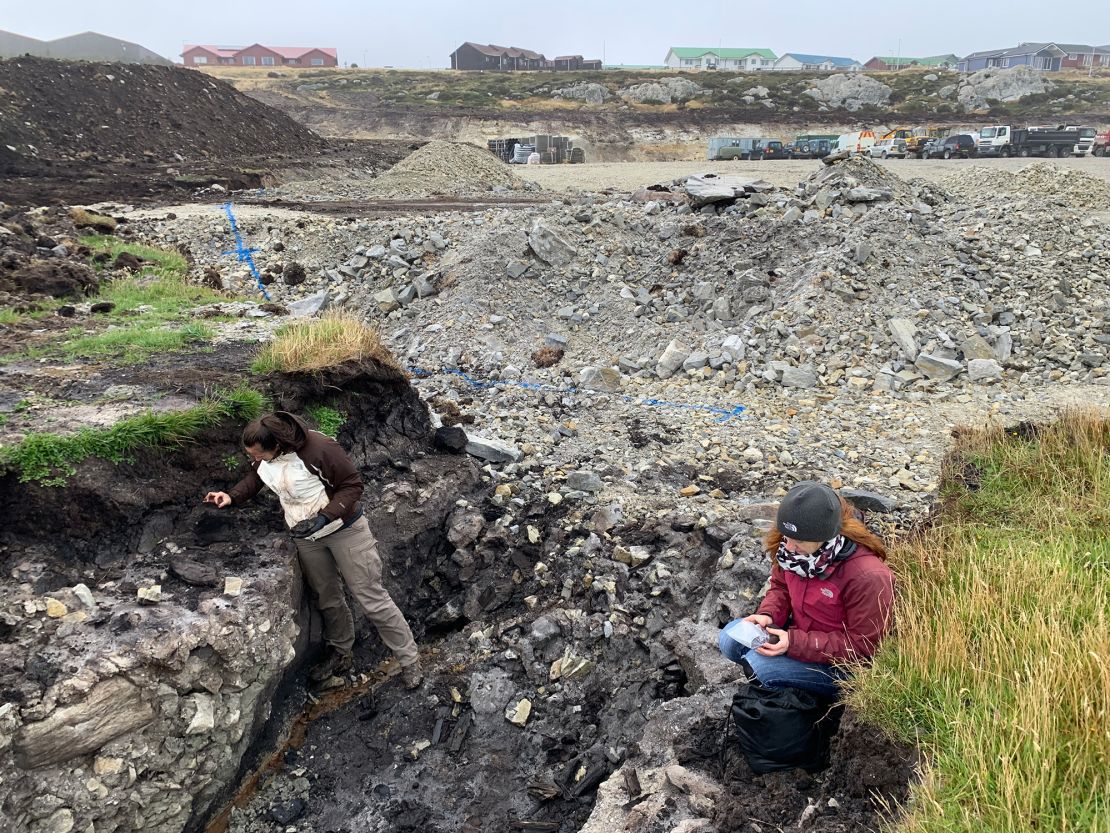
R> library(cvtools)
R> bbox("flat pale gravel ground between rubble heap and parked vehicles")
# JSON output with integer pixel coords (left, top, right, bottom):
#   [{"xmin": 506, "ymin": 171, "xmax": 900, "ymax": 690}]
[{"xmin": 517, "ymin": 157, "xmax": 1110, "ymax": 191}]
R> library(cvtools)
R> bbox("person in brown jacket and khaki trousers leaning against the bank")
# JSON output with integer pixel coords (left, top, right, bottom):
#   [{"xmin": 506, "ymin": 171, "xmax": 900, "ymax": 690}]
[{"xmin": 204, "ymin": 411, "xmax": 423, "ymax": 689}]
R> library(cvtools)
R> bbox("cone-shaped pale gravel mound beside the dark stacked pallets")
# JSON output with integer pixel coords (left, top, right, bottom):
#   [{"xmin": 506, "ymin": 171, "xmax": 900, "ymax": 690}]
[{"xmin": 374, "ymin": 141, "xmax": 525, "ymax": 197}]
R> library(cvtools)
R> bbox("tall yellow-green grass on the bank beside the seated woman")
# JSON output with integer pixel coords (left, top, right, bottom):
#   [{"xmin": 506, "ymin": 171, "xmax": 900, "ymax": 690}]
[{"xmin": 850, "ymin": 414, "xmax": 1110, "ymax": 833}]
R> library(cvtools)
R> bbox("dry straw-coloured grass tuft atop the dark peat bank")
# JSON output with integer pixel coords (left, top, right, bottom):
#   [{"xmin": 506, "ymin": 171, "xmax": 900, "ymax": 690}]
[{"xmin": 251, "ymin": 315, "xmax": 400, "ymax": 373}]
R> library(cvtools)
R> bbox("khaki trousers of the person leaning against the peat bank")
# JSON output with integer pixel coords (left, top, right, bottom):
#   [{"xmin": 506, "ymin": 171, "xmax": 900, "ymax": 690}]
[{"xmin": 294, "ymin": 518, "xmax": 417, "ymax": 665}]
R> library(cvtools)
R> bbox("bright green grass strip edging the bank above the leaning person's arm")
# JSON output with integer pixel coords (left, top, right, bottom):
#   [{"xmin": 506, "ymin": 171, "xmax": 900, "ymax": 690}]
[{"xmin": 0, "ymin": 388, "xmax": 268, "ymax": 486}]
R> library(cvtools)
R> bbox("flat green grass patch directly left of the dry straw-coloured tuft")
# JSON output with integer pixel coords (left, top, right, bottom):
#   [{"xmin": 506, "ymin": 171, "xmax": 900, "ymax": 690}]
[{"xmin": 15, "ymin": 321, "xmax": 214, "ymax": 364}]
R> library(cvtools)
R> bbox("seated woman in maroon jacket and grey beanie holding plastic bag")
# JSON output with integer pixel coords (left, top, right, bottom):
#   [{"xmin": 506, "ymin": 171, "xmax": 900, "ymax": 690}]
[{"xmin": 719, "ymin": 482, "xmax": 894, "ymax": 697}]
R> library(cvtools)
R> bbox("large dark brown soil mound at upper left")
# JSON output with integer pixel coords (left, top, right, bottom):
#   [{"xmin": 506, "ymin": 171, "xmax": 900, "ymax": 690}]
[{"xmin": 0, "ymin": 58, "xmax": 322, "ymax": 162}]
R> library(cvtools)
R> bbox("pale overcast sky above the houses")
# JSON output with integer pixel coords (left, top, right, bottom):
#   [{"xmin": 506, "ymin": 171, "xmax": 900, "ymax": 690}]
[{"xmin": 0, "ymin": 0, "xmax": 1110, "ymax": 68}]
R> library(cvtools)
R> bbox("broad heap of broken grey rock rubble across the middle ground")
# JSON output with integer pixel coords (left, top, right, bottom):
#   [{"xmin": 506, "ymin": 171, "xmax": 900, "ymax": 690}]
[{"xmin": 136, "ymin": 157, "xmax": 1110, "ymax": 395}]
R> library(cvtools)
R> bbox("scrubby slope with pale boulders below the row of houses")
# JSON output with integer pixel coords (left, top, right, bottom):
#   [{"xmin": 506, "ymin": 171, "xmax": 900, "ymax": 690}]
[{"xmin": 211, "ymin": 68, "xmax": 1110, "ymax": 123}]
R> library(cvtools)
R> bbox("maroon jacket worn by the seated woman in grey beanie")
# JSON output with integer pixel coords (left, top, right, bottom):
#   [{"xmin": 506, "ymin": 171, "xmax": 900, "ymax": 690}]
[{"xmin": 758, "ymin": 544, "xmax": 895, "ymax": 663}]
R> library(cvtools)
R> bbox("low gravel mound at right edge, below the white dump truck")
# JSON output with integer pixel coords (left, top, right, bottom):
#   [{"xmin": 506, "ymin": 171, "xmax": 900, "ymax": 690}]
[{"xmin": 944, "ymin": 162, "xmax": 1110, "ymax": 209}]
